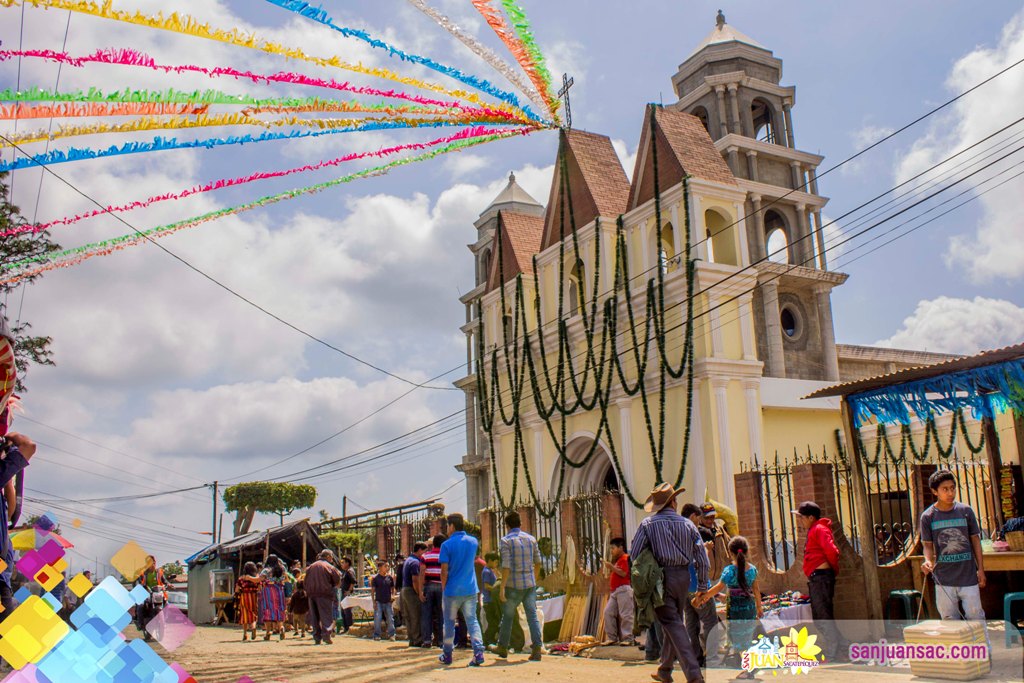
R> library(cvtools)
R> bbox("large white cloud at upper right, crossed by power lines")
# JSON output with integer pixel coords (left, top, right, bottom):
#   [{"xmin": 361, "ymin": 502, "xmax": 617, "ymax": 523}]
[{"xmin": 897, "ymin": 10, "xmax": 1024, "ymax": 283}]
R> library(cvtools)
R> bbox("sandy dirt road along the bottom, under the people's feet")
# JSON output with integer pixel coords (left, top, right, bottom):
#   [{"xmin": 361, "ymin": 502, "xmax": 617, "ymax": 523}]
[{"xmin": 163, "ymin": 627, "xmax": 1021, "ymax": 683}]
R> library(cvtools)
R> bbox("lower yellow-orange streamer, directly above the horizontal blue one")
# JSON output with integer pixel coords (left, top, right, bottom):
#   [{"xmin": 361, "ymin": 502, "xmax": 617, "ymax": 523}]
[{"xmin": 0, "ymin": 112, "xmax": 520, "ymax": 148}]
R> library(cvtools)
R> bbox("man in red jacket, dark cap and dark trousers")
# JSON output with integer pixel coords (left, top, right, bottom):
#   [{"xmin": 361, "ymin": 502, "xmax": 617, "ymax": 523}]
[{"xmin": 793, "ymin": 501, "xmax": 847, "ymax": 661}]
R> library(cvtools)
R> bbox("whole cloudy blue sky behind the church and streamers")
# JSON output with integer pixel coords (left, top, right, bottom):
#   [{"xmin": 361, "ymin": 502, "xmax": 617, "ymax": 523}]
[{"xmin": 0, "ymin": 0, "xmax": 1024, "ymax": 568}]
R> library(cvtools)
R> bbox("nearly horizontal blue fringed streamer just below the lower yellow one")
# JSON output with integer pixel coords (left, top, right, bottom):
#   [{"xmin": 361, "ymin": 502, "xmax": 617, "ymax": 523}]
[{"xmin": 0, "ymin": 121, "xmax": 512, "ymax": 173}]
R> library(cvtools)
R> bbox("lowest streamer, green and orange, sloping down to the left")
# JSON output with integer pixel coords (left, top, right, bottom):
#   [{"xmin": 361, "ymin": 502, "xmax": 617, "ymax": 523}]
[{"xmin": 0, "ymin": 127, "xmax": 537, "ymax": 285}]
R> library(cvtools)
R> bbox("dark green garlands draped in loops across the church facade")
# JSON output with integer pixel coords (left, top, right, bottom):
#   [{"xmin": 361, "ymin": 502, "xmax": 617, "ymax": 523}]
[{"xmin": 476, "ymin": 111, "xmax": 696, "ymax": 517}]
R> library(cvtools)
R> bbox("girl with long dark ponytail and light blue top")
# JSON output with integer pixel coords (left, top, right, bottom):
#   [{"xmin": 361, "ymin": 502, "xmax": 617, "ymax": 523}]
[{"xmin": 693, "ymin": 536, "xmax": 764, "ymax": 680}]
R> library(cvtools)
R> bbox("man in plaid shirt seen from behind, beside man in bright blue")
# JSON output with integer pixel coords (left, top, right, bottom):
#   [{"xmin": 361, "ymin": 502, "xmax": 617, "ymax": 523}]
[{"xmin": 495, "ymin": 510, "xmax": 544, "ymax": 661}]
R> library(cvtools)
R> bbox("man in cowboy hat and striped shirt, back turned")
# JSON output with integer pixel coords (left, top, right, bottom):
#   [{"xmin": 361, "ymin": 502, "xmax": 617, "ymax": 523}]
[{"xmin": 633, "ymin": 483, "xmax": 710, "ymax": 683}]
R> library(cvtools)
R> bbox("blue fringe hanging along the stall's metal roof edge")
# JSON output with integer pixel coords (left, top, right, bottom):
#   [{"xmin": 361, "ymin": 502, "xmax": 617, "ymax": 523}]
[{"xmin": 847, "ymin": 358, "xmax": 1024, "ymax": 427}]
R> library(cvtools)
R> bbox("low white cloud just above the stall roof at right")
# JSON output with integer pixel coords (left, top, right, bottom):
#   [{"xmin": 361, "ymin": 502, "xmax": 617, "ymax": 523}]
[{"xmin": 876, "ymin": 296, "xmax": 1024, "ymax": 354}]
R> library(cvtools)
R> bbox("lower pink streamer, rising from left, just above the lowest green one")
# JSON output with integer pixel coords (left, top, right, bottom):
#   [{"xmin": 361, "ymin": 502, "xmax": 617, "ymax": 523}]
[{"xmin": 6, "ymin": 128, "xmax": 520, "ymax": 237}]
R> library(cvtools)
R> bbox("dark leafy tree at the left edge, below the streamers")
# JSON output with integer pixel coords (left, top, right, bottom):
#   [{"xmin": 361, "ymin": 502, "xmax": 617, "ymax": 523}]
[{"xmin": 0, "ymin": 173, "xmax": 60, "ymax": 393}]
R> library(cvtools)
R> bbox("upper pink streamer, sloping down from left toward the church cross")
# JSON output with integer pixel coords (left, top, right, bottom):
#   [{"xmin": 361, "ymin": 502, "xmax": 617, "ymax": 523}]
[{"xmin": 0, "ymin": 48, "xmax": 536, "ymax": 124}]
